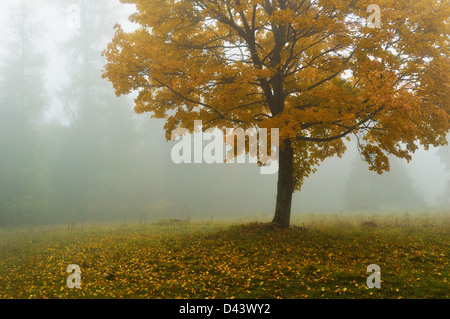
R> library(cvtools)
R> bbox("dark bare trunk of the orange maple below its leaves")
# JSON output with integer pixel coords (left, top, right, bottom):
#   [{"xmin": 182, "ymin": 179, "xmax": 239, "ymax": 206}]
[{"xmin": 272, "ymin": 140, "xmax": 294, "ymax": 228}]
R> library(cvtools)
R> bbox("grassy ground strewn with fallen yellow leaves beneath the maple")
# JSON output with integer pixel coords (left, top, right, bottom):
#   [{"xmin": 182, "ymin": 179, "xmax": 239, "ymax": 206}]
[{"xmin": 0, "ymin": 213, "xmax": 450, "ymax": 299}]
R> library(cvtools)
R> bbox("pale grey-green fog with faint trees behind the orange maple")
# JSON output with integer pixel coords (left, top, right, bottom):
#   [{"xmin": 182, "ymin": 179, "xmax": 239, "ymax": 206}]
[{"xmin": 0, "ymin": 0, "xmax": 450, "ymax": 228}]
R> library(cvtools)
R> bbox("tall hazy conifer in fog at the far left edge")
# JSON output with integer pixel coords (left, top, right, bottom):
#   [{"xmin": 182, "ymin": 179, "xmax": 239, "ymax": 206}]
[{"xmin": 0, "ymin": 1, "xmax": 50, "ymax": 226}]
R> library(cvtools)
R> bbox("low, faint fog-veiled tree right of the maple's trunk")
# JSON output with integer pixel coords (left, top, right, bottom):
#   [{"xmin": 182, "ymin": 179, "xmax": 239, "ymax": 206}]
[{"xmin": 345, "ymin": 156, "xmax": 426, "ymax": 211}]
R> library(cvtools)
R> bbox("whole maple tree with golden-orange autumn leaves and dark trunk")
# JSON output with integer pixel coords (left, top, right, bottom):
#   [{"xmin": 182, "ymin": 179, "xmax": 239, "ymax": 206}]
[{"xmin": 103, "ymin": 0, "xmax": 450, "ymax": 227}]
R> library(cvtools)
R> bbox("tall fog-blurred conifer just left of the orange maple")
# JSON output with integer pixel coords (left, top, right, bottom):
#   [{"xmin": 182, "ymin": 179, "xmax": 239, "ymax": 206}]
[{"xmin": 47, "ymin": 0, "xmax": 142, "ymax": 224}]
